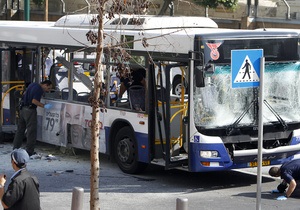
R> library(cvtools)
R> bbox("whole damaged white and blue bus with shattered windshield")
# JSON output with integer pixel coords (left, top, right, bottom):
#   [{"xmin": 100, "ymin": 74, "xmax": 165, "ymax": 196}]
[{"xmin": 0, "ymin": 15, "xmax": 300, "ymax": 173}]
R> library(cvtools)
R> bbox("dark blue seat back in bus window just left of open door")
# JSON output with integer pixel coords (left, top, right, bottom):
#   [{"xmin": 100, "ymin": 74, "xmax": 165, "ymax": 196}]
[{"xmin": 128, "ymin": 85, "xmax": 145, "ymax": 111}]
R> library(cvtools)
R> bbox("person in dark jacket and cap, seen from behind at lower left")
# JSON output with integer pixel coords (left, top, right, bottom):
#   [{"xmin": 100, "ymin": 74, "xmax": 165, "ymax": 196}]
[{"xmin": 0, "ymin": 149, "xmax": 41, "ymax": 210}]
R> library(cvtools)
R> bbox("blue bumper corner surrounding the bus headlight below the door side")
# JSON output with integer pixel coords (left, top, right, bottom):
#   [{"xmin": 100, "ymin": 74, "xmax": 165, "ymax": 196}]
[{"xmin": 189, "ymin": 143, "xmax": 233, "ymax": 172}]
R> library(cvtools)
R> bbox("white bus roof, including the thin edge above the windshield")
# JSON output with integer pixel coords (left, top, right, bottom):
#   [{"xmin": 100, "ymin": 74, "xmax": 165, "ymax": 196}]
[{"xmin": 0, "ymin": 15, "xmax": 297, "ymax": 54}]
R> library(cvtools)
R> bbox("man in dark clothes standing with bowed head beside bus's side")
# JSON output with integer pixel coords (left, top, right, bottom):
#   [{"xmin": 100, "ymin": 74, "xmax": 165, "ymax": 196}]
[{"xmin": 13, "ymin": 80, "xmax": 52, "ymax": 156}]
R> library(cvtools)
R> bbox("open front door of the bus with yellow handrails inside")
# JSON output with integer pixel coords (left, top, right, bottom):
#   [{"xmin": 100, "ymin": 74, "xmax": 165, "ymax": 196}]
[{"xmin": 154, "ymin": 63, "xmax": 187, "ymax": 169}]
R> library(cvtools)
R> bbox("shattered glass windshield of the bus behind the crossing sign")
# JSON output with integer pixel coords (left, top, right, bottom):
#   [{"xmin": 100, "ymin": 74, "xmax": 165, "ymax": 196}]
[{"xmin": 193, "ymin": 62, "xmax": 300, "ymax": 128}]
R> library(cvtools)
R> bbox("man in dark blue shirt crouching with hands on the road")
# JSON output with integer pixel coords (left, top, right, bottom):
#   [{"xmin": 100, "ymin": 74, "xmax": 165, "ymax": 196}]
[{"xmin": 269, "ymin": 159, "xmax": 300, "ymax": 200}]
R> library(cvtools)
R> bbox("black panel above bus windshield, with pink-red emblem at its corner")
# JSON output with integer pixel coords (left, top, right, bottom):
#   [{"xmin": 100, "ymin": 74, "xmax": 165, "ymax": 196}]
[{"xmin": 199, "ymin": 36, "xmax": 300, "ymax": 64}]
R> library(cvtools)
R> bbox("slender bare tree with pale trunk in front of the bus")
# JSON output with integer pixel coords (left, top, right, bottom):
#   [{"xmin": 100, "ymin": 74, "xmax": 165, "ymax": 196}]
[{"xmin": 86, "ymin": 0, "xmax": 148, "ymax": 210}]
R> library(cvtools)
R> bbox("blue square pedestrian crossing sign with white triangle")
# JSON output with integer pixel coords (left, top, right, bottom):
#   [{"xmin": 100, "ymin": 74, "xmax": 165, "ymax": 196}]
[{"xmin": 231, "ymin": 49, "xmax": 263, "ymax": 88}]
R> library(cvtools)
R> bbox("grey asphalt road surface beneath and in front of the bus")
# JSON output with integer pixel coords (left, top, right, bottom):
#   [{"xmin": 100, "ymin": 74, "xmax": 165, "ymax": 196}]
[{"xmin": 0, "ymin": 142, "xmax": 300, "ymax": 210}]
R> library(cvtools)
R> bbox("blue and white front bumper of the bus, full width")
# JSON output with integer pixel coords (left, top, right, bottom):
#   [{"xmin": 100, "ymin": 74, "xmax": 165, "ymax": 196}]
[{"xmin": 189, "ymin": 143, "xmax": 300, "ymax": 172}]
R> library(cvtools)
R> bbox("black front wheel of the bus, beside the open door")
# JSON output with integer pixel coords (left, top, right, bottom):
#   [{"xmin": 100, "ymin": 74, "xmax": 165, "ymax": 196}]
[{"xmin": 114, "ymin": 126, "xmax": 148, "ymax": 174}]
